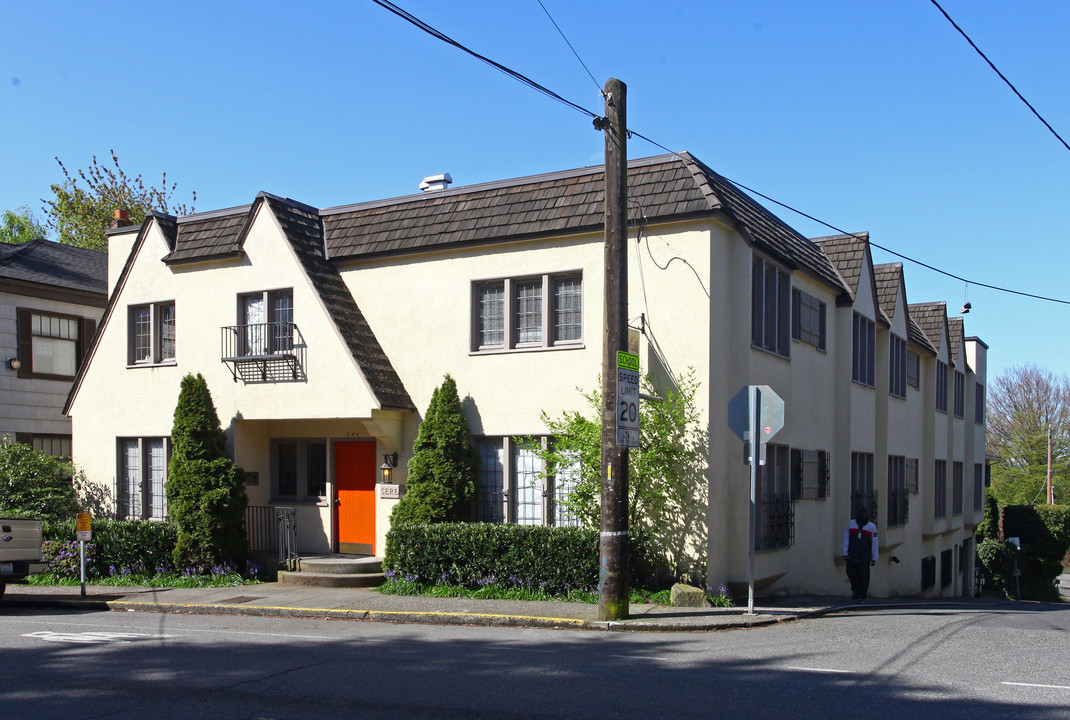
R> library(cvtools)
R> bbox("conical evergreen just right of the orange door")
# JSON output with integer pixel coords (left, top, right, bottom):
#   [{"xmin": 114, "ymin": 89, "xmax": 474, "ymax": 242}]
[{"xmin": 391, "ymin": 374, "xmax": 476, "ymax": 523}]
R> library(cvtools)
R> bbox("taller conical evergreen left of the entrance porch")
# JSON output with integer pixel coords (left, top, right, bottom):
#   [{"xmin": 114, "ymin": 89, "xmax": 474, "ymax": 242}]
[{"xmin": 167, "ymin": 373, "xmax": 248, "ymax": 569}]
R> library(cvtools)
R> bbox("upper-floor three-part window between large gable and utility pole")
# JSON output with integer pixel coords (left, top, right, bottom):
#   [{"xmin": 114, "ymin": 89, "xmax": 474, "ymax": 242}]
[{"xmin": 472, "ymin": 273, "xmax": 583, "ymax": 352}]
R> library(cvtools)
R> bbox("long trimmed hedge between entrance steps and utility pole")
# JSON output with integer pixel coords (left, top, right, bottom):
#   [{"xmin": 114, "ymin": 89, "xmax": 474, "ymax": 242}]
[{"xmin": 383, "ymin": 522, "xmax": 645, "ymax": 595}]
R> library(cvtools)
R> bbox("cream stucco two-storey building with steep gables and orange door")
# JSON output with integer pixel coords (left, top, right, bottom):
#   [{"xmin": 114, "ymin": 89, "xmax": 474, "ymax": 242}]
[{"xmin": 67, "ymin": 153, "xmax": 987, "ymax": 596}]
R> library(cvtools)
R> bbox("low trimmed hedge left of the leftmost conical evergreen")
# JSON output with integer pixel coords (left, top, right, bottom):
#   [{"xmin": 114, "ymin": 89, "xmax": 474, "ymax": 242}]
[{"xmin": 41, "ymin": 518, "xmax": 177, "ymax": 578}]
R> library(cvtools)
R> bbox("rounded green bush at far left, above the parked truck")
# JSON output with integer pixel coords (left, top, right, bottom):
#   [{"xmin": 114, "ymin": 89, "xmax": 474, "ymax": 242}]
[{"xmin": 0, "ymin": 436, "xmax": 82, "ymax": 520}]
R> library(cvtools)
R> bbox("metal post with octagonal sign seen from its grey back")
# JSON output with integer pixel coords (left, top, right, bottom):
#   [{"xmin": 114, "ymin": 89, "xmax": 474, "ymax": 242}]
[{"xmin": 729, "ymin": 385, "xmax": 784, "ymax": 615}]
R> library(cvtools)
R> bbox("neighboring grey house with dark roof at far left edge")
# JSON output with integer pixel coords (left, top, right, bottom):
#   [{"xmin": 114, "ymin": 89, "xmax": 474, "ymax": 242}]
[{"xmin": 0, "ymin": 240, "xmax": 107, "ymax": 457}]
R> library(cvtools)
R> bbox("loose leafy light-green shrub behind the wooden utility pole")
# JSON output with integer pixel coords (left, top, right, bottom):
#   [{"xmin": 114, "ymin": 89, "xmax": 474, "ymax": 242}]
[{"xmin": 526, "ymin": 371, "xmax": 706, "ymax": 530}]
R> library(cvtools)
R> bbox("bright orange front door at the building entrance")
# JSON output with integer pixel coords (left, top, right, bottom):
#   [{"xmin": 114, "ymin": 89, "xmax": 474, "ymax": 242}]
[{"xmin": 334, "ymin": 440, "xmax": 376, "ymax": 555}]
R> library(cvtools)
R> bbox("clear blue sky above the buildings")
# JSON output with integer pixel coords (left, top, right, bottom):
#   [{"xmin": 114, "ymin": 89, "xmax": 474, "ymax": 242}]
[{"xmin": 0, "ymin": 0, "xmax": 1070, "ymax": 379}]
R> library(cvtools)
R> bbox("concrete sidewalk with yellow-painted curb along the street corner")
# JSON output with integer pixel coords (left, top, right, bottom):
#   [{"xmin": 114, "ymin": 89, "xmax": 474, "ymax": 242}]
[{"xmin": 0, "ymin": 583, "xmax": 1005, "ymax": 632}]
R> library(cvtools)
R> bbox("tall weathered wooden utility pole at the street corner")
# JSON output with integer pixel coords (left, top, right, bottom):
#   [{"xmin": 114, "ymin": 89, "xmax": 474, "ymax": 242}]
[{"xmin": 598, "ymin": 78, "xmax": 629, "ymax": 621}]
